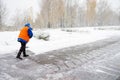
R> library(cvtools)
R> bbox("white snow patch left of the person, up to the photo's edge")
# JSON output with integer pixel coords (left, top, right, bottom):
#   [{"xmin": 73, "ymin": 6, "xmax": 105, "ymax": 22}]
[{"xmin": 0, "ymin": 31, "xmax": 19, "ymax": 54}]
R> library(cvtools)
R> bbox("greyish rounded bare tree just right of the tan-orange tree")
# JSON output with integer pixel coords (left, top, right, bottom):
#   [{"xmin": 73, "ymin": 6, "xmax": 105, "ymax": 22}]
[{"xmin": 97, "ymin": 0, "xmax": 114, "ymax": 26}]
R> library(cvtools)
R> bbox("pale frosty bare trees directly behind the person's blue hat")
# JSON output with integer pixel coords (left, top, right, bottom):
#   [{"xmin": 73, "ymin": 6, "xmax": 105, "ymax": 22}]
[{"xmin": 13, "ymin": 7, "xmax": 34, "ymax": 30}]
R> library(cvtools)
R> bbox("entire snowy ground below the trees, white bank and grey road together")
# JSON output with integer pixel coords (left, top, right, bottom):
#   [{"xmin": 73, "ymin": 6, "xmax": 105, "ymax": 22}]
[{"xmin": 0, "ymin": 26, "xmax": 120, "ymax": 80}]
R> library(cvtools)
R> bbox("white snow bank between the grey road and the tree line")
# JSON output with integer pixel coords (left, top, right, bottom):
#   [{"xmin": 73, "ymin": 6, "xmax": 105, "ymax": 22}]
[{"xmin": 0, "ymin": 26, "xmax": 120, "ymax": 54}]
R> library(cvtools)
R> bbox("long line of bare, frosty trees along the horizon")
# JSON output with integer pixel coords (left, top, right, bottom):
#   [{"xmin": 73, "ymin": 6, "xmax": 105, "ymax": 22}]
[{"xmin": 0, "ymin": 0, "xmax": 120, "ymax": 30}]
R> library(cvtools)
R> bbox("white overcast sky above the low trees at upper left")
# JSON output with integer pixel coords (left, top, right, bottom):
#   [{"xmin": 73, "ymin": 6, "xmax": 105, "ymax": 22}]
[{"xmin": 4, "ymin": 0, "xmax": 39, "ymax": 24}]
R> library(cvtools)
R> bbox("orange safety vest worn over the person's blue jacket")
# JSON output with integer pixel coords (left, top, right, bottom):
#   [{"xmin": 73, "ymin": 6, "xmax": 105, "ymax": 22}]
[{"xmin": 19, "ymin": 26, "xmax": 30, "ymax": 42}]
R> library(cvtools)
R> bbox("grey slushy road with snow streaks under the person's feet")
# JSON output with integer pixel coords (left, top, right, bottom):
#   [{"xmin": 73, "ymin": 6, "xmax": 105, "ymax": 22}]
[{"xmin": 0, "ymin": 37, "xmax": 120, "ymax": 80}]
